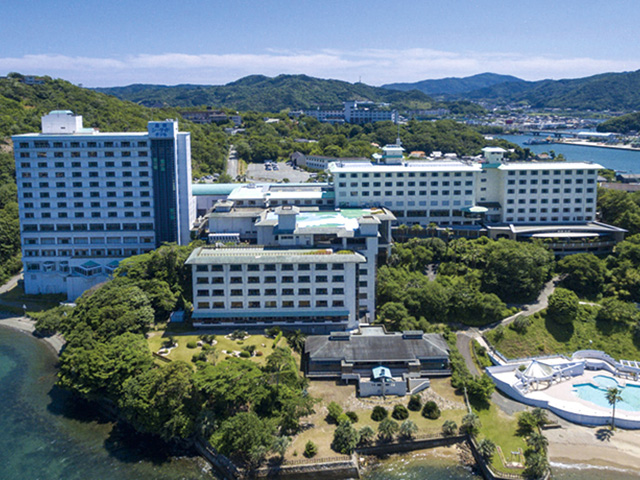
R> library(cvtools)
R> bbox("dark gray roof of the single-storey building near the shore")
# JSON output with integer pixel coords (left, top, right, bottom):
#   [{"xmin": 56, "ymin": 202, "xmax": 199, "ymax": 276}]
[{"xmin": 305, "ymin": 327, "xmax": 449, "ymax": 363}]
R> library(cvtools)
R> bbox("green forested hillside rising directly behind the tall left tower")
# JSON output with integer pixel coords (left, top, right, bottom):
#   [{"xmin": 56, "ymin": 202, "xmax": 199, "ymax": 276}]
[{"xmin": 0, "ymin": 73, "xmax": 227, "ymax": 173}]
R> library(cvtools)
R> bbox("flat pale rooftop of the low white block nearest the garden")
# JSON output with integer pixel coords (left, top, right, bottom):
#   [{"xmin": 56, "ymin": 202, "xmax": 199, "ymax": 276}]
[{"xmin": 185, "ymin": 246, "xmax": 366, "ymax": 265}]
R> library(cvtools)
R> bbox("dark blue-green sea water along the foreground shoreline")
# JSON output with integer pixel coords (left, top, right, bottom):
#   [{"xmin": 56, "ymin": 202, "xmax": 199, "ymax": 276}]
[{"xmin": 0, "ymin": 327, "xmax": 639, "ymax": 480}]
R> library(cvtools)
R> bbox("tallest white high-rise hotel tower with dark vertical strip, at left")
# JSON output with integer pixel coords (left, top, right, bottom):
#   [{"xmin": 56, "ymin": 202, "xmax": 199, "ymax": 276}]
[{"xmin": 13, "ymin": 110, "xmax": 195, "ymax": 299}]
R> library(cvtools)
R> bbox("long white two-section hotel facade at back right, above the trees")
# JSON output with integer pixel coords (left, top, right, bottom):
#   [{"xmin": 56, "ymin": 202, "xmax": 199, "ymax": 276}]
[{"xmin": 329, "ymin": 161, "xmax": 602, "ymax": 226}]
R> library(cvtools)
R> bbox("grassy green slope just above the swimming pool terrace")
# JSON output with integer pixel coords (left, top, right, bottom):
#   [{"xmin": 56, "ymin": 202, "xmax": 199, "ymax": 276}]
[{"xmin": 487, "ymin": 306, "xmax": 640, "ymax": 360}]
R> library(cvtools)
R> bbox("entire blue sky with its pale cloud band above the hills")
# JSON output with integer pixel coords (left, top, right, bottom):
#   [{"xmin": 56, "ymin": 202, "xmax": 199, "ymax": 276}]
[{"xmin": 0, "ymin": 0, "xmax": 640, "ymax": 86}]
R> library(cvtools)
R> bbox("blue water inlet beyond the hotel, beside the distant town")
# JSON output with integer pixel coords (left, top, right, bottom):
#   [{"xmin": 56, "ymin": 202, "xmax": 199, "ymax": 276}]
[{"xmin": 500, "ymin": 135, "xmax": 640, "ymax": 173}]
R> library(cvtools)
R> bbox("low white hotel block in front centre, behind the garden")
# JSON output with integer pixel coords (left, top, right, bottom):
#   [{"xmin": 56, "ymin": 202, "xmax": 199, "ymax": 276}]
[{"xmin": 186, "ymin": 247, "xmax": 365, "ymax": 333}]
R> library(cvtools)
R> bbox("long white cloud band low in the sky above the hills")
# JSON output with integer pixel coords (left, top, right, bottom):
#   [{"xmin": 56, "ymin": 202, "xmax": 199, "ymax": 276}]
[{"xmin": 0, "ymin": 48, "xmax": 640, "ymax": 86}]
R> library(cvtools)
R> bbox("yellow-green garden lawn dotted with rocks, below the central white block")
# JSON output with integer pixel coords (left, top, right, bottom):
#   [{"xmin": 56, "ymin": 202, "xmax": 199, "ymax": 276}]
[{"xmin": 148, "ymin": 326, "xmax": 278, "ymax": 365}]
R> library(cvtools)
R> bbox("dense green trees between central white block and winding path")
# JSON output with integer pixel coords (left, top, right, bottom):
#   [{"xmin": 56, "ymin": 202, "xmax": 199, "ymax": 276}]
[{"xmin": 377, "ymin": 237, "xmax": 554, "ymax": 330}]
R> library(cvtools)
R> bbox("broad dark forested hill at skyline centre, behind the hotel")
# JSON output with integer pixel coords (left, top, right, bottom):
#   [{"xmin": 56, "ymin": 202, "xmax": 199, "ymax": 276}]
[{"xmin": 96, "ymin": 75, "xmax": 444, "ymax": 112}]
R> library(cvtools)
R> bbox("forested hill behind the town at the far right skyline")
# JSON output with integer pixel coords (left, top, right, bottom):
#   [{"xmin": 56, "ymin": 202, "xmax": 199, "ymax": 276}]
[{"xmin": 460, "ymin": 70, "xmax": 640, "ymax": 111}]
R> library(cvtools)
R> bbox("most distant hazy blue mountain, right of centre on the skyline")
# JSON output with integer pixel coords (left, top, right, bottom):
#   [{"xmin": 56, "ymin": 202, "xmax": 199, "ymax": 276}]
[{"xmin": 382, "ymin": 73, "xmax": 524, "ymax": 96}]
